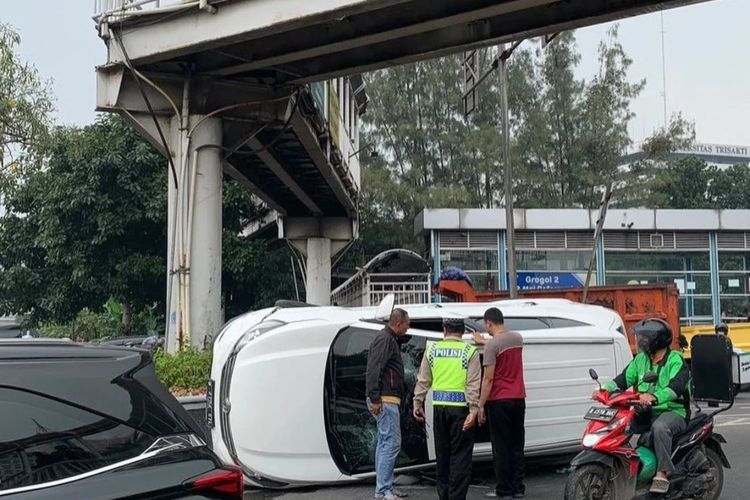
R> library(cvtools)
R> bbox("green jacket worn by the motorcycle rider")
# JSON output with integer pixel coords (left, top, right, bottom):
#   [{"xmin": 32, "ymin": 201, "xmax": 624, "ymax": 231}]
[{"xmin": 604, "ymin": 349, "xmax": 690, "ymax": 418}]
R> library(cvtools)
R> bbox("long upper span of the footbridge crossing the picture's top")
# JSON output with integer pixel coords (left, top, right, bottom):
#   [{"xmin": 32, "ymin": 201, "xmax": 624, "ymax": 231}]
[{"xmin": 104, "ymin": 0, "xmax": 705, "ymax": 85}]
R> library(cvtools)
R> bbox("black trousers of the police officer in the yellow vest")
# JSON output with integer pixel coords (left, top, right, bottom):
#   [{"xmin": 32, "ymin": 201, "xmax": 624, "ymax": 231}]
[{"xmin": 433, "ymin": 406, "xmax": 474, "ymax": 500}]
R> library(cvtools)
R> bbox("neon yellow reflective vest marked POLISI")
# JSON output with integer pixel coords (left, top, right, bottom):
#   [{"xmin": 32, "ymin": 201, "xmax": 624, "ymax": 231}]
[{"xmin": 427, "ymin": 340, "xmax": 477, "ymax": 406}]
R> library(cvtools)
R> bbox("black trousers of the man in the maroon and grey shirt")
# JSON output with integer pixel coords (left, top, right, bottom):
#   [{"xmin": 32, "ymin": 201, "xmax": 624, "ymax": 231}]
[{"xmin": 485, "ymin": 399, "xmax": 526, "ymax": 497}]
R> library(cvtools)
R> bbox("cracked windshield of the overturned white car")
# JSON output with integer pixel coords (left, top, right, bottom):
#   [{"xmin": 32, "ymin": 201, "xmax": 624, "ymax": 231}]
[{"xmin": 325, "ymin": 327, "xmax": 428, "ymax": 474}]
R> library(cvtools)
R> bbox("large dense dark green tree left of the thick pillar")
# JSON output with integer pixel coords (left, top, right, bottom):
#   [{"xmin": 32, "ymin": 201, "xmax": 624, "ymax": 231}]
[{"xmin": 0, "ymin": 116, "xmax": 167, "ymax": 322}]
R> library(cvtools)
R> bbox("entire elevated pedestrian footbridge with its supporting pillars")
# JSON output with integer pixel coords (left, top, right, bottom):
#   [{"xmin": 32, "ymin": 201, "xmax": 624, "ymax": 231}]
[{"xmin": 94, "ymin": 0, "xmax": 716, "ymax": 345}]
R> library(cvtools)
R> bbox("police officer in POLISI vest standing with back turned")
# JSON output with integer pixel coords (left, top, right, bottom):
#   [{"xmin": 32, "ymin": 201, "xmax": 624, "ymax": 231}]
[{"xmin": 413, "ymin": 319, "xmax": 482, "ymax": 500}]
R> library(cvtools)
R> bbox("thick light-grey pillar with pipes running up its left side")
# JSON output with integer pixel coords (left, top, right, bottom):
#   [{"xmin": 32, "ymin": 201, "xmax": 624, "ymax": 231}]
[{"xmin": 167, "ymin": 115, "xmax": 224, "ymax": 351}]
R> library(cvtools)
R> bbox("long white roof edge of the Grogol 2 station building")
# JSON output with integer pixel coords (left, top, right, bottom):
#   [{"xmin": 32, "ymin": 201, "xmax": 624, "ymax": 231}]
[{"xmin": 414, "ymin": 208, "xmax": 750, "ymax": 234}]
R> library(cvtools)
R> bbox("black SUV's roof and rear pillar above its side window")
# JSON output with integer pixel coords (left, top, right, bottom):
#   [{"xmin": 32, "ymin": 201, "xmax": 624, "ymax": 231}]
[{"xmin": 0, "ymin": 339, "xmax": 204, "ymax": 436}]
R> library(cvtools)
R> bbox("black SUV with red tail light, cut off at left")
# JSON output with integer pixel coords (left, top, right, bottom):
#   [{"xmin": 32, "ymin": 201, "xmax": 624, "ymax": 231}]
[{"xmin": 0, "ymin": 339, "xmax": 243, "ymax": 500}]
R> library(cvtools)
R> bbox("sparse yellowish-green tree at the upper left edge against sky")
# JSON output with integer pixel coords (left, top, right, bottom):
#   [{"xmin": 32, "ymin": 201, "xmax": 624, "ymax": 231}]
[{"xmin": 0, "ymin": 23, "xmax": 53, "ymax": 186}]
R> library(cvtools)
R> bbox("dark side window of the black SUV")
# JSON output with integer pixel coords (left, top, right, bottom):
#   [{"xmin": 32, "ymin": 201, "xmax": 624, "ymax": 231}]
[{"xmin": 0, "ymin": 388, "xmax": 154, "ymax": 492}]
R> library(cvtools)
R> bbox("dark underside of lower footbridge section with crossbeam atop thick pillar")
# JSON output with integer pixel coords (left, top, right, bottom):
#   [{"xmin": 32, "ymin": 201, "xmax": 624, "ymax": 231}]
[{"xmin": 97, "ymin": 66, "xmax": 358, "ymax": 217}]
